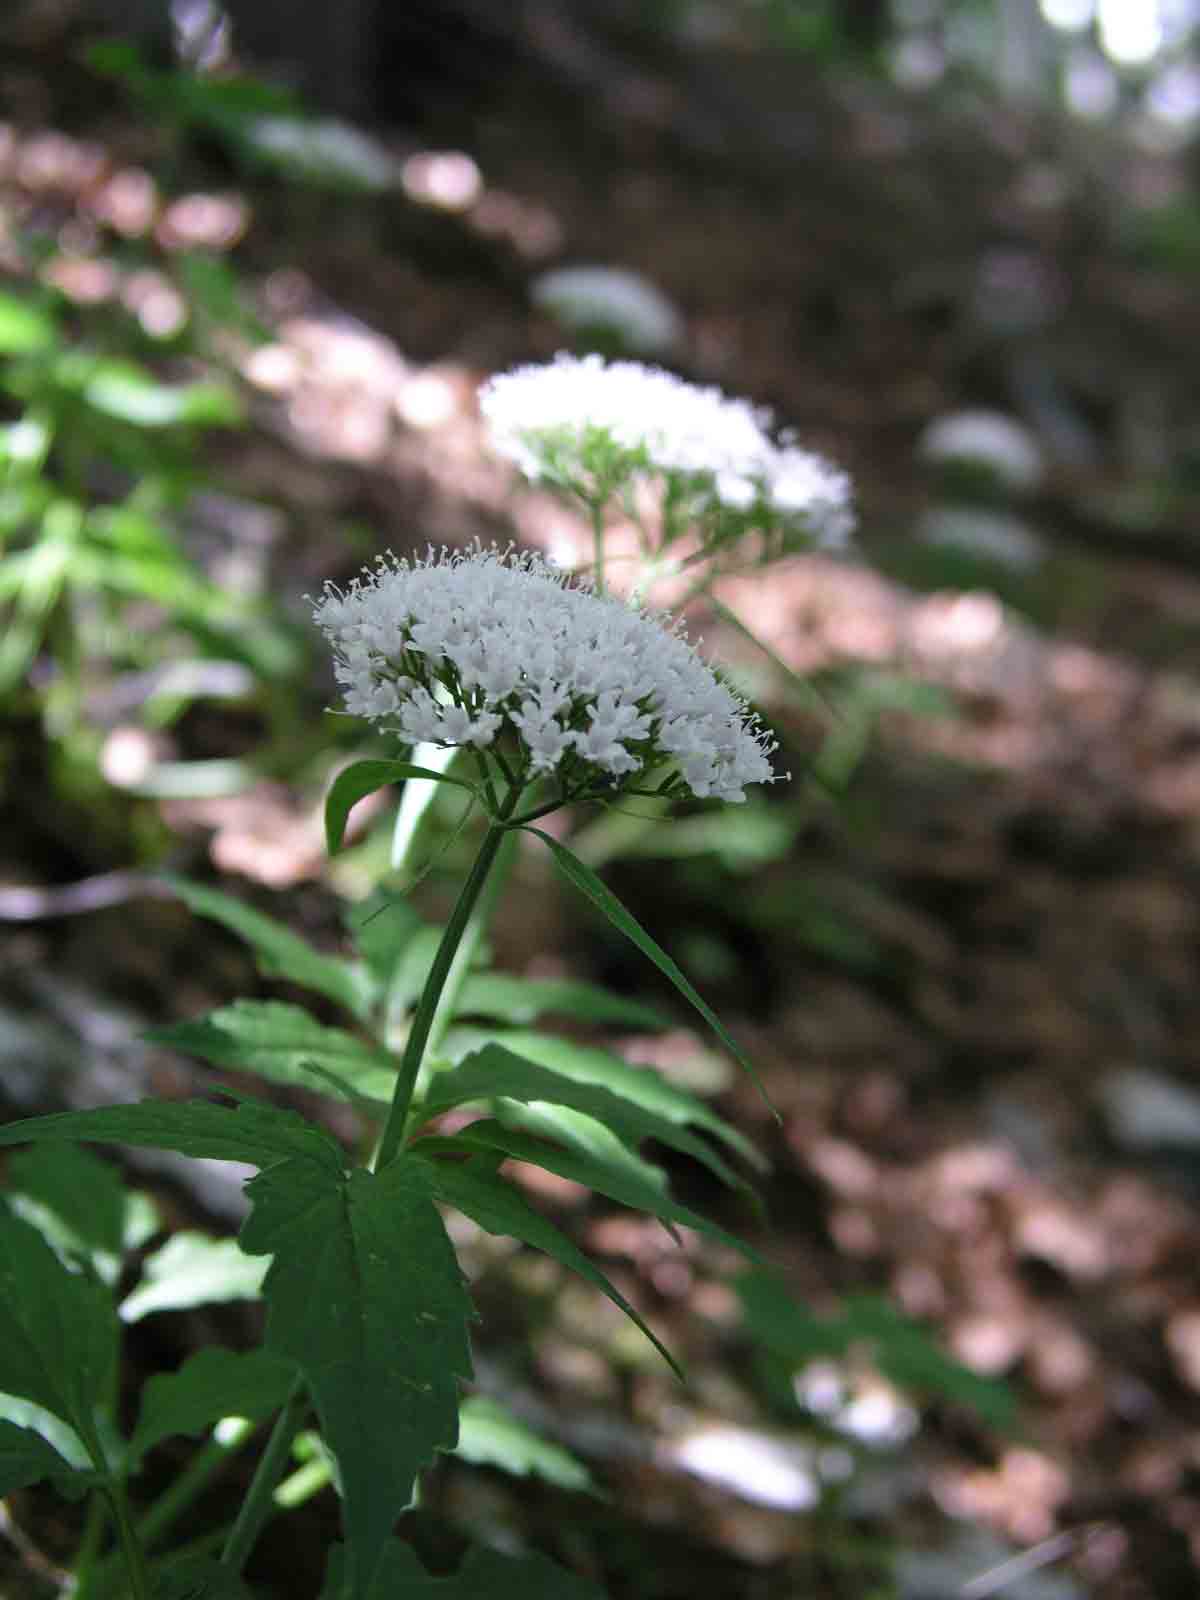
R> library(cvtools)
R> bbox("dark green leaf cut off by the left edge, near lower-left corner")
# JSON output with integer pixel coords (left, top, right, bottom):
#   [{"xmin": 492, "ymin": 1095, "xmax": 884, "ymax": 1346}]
[{"xmin": 0, "ymin": 1210, "xmax": 117, "ymax": 1451}]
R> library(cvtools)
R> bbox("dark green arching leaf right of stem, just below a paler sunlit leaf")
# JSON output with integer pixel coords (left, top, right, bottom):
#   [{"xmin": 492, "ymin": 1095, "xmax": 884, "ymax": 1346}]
[{"xmin": 421, "ymin": 1045, "xmax": 747, "ymax": 1189}]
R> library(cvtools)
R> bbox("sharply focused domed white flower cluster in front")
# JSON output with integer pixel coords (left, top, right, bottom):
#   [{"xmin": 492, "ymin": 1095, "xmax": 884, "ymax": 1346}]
[{"xmin": 314, "ymin": 549, "xmax": 776, "ymax": 802}]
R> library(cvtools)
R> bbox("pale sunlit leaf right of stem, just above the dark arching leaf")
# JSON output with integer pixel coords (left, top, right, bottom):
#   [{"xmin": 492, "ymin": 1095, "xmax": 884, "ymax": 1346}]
[{"xmin": 440, "ymin": 1027, "xmax": 766, "ymax": 1170}]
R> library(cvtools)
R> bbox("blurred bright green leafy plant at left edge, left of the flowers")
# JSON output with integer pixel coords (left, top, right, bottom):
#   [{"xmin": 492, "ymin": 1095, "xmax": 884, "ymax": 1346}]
[{"xmin": 0, "ymin": 281, "xmax": 301, "ymax": 780}]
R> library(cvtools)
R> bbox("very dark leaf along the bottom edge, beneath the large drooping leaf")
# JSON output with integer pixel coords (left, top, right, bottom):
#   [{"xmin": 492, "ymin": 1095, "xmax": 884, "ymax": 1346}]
[{"xmin": 322, "ymin": 1539, "xmax": 605, "ymax": 1600}]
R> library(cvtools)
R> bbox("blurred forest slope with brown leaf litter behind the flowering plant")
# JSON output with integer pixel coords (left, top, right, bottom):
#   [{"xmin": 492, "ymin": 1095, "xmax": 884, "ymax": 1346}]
[{"xmin": 0, "ymin": 0, "xmax": 1200, "ymax": 1600}]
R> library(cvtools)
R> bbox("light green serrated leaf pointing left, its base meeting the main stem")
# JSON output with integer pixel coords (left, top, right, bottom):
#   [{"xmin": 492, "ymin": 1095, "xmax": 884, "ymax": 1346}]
[{"xmin": 144, "ymin": 1000, "xmax": 395, "ymax": 1106}]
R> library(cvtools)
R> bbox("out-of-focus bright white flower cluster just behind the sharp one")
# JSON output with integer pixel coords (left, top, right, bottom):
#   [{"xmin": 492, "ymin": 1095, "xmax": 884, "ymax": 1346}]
[{"xmin": 480, "ymin": 354, "xmax": 854, "ymax": 546}]
